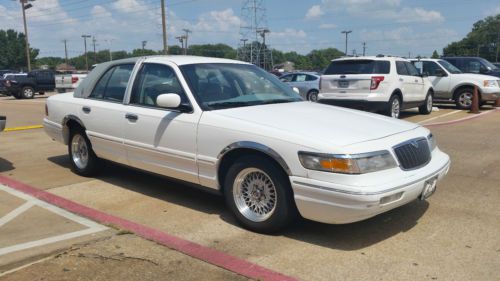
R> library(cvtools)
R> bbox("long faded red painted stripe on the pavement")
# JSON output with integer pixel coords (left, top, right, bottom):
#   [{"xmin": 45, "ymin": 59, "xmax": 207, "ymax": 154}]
[{"xmin": 0, "ymin": 175, "xmax": 297, "ymax": 281}]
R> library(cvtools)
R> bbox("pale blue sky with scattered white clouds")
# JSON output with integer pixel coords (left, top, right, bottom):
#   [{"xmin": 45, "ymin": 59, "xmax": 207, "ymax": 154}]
[{"xmin": 0, "ymin": 0, "xmax": 500, "ymax": 57}]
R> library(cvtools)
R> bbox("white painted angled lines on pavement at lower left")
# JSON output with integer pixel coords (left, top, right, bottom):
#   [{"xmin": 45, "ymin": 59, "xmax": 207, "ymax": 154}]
[{"xmin": 0, "ymin": 182, "xmax": 108, "ymax": 256}]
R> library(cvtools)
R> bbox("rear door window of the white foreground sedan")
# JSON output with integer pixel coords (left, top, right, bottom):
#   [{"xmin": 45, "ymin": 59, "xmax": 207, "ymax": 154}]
[{"xmin": 89, "ymin": 64, "xmax": 134, "ymax": 102}]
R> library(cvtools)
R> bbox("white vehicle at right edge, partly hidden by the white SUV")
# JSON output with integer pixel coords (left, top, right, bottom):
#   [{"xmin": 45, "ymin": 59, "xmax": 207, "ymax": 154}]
[{"xmin": 412, "ymin": 59, "xmax": 500, "ymax": 109}]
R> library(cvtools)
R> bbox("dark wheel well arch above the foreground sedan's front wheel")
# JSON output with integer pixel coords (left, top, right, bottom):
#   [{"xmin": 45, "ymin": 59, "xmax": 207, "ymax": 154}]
[{"xmin": 217, "ymin": 148, "xmax": 288, "ymax": 192}]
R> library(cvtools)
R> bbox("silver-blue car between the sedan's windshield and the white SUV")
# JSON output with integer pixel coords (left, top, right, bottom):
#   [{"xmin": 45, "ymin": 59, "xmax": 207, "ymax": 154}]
[{"xmin": 280, "ymin": 72, "xmax": 320, "ymax": 102}]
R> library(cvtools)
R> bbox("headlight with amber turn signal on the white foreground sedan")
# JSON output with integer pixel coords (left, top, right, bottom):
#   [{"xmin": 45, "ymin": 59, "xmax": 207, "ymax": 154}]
[{"xmin": 299, "ymin": 150, "xmax": 397, "ymax": 174}]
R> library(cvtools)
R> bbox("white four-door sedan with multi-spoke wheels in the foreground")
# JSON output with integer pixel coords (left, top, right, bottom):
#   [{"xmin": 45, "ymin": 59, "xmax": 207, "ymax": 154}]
[{"xmin": 43, "ymin": 56, "xmax": 450, "ymax": 232}]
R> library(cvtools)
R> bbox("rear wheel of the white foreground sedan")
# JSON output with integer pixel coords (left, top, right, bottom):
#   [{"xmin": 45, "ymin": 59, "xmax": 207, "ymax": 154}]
[{"xmin": 68, "ymin": 128, "xmax": 99, "ymax": 177}]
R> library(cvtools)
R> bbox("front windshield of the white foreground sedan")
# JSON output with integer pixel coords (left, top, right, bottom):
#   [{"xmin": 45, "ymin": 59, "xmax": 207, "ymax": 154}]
[{"xmin": 180, "ymin": 63, "xmax": 302, "ymax": 110}]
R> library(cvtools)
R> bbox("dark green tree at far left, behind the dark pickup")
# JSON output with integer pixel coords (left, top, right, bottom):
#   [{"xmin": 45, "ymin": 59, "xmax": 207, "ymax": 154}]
[{"xmin": 0, "ymin": 29, "xmax": 39, "ymax": 69}]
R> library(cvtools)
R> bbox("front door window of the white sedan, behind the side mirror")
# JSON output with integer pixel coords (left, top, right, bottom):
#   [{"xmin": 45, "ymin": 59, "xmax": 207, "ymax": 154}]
[{"xmin": 130, "ymin": 63, "xmax": 188, "ymax": 107}]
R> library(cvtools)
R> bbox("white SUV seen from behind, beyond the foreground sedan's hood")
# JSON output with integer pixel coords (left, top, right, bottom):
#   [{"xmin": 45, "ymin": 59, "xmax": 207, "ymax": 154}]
[{"xmin": 318, "ymin": 55, "xmax": 434, "ymax": 118}]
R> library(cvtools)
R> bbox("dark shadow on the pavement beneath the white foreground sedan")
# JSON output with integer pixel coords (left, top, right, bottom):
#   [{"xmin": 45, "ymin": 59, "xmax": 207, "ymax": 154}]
[{"xmin": 48, "ymin": 155, "xmax": 429, "ymax": 251}]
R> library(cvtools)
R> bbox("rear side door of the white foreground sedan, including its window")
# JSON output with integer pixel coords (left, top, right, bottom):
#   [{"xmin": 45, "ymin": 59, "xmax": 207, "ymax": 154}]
[{"xmin": 78, "ymin": 64, "xmax": 134, "ymax": 163}]
